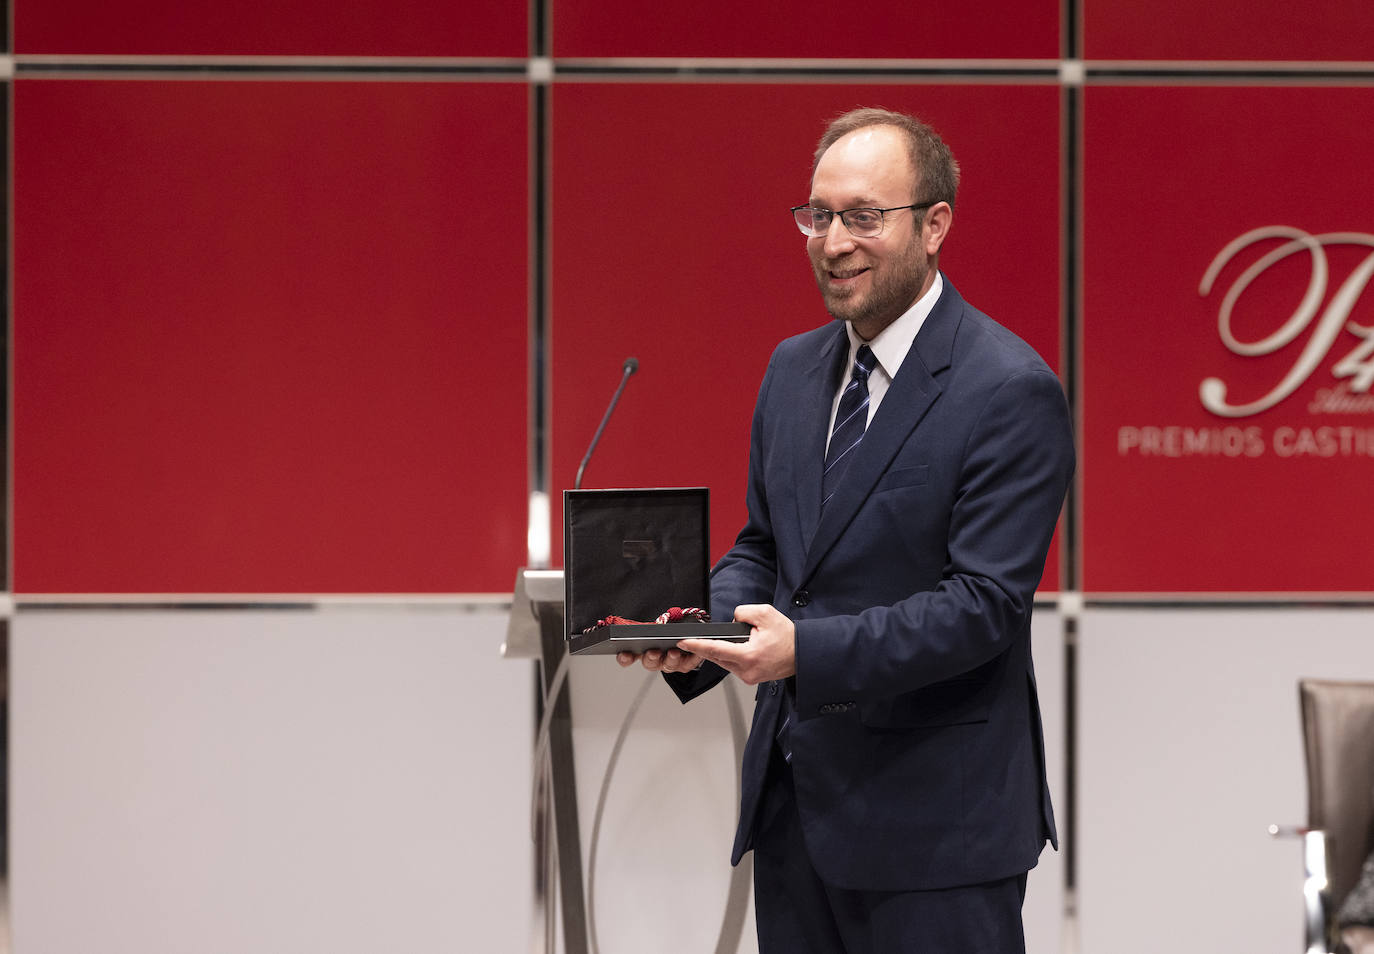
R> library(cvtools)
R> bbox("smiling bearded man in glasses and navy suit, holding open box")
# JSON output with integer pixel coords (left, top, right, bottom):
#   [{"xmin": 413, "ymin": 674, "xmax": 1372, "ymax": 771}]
[{"xmin": 620, "ymin": 110, "xmax": 1073, "ymax": 954}]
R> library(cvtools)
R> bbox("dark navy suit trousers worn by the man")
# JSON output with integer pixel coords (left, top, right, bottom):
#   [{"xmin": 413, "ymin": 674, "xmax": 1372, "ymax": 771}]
[{"xmin": 754, "ymin": 745, "xmax": 1026, "ymax": 954}]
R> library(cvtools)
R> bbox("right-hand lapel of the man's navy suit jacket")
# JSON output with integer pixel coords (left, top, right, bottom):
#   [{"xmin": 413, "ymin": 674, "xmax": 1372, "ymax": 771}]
[{"xmin": 800, "ymin": 282, "xmax": 963, "ymax": 580}]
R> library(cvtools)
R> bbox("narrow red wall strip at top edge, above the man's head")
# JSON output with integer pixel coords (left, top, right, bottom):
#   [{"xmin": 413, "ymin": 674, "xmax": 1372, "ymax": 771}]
[{"xmin": 552, "ymin": 0, "xmax": 1061, "ymax": 59}]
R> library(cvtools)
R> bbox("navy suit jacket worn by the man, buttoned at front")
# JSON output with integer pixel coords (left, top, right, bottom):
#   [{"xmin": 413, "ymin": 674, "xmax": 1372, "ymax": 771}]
[{"xmin": 668, "ymin": 280, "xmax": 1074, "ymax": 891}]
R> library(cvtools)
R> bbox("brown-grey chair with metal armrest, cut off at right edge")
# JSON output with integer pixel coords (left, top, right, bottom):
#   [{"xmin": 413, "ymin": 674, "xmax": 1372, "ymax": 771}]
[{"xmin": 1280, "ymin": 679, "xmax": 1374, "ymax": 954}]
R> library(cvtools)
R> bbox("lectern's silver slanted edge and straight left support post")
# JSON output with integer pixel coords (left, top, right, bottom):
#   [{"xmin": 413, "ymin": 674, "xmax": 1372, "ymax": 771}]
[{"xmin": 502, "ymin": 569, "xmax": 587, "ymax": 954}]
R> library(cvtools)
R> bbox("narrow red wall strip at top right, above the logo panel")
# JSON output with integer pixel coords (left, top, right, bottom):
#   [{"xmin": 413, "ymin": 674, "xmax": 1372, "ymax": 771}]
[{"xmin": 1083, "ymin": 0, "xmax": 1374, "ymax": 62}]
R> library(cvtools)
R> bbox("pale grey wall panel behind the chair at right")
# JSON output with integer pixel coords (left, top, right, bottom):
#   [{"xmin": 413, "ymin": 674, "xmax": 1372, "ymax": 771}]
[{"xmin": 1079, "ymin": 609, "xmax": 1374, "ymax": 954}]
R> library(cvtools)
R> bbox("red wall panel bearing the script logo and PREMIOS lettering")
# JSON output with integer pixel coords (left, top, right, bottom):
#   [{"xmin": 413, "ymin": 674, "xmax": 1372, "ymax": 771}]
[{"xmin": 1083, "ymin": 88, "xmax": 1374, "ymax": 592}]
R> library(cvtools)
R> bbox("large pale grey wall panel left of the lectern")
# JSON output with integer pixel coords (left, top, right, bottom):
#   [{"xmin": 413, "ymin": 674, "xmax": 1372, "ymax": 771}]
[{"xmin": 11, "ymin": 608, "xmax": 533, "ymax": 954}]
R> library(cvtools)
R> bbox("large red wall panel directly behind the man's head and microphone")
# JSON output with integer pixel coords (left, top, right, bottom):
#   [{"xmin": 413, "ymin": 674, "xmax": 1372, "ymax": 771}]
[{"xmin": 552, "ymin": 84, "xmax": 1059, "ymax": 599}]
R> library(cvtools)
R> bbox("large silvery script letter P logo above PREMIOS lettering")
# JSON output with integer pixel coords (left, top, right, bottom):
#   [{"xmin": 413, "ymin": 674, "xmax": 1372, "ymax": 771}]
[{"xmin": 1198, "ymin": 225, "xmax": 1374, "ymax": 418}]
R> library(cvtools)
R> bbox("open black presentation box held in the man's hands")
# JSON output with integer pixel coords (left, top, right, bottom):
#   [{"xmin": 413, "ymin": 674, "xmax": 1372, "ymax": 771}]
[{"xmin": 563, "ymin": 487, "xmax": 750, "ymax": 654}]
